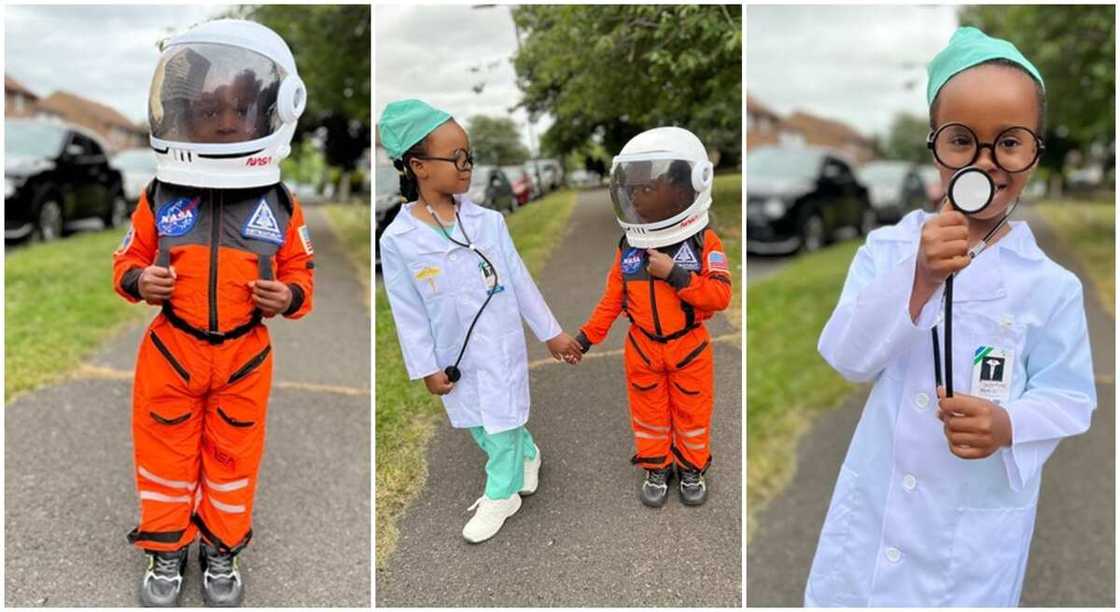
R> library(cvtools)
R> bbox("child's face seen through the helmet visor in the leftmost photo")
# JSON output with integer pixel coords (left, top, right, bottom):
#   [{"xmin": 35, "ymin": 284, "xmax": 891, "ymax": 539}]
[{"xmin": 188, "ymin": 77, "xmax": 266, "ymax": 142}]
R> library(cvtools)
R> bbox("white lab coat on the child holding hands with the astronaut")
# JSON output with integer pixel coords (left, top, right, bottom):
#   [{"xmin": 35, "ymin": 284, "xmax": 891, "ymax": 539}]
[{"xmin": 380, "ymin": 196, "xmax": 561, "ymax": 434}]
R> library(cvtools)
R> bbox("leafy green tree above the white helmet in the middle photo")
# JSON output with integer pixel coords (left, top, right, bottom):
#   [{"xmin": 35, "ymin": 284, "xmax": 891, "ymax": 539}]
[{"xmin": 513, "ymin": 4, "xmax": 743, "ymax": 164}]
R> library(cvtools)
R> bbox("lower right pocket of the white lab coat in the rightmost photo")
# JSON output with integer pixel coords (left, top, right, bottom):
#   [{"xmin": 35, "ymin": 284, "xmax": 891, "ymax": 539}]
[{"xmin": 945, "ymin": 506, "xmax": 1034, "ymax": 606}]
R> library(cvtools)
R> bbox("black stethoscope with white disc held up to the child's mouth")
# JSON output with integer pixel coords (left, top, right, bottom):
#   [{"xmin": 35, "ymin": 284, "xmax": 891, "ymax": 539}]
[{"xmin": 931, "ymin": 166, "xmax": 1019, "ymax": 398}]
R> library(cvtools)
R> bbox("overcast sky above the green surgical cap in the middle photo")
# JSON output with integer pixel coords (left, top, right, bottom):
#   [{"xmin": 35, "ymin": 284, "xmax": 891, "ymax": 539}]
[{"xmin": 373, "ymin": 4, "xmax": 552, "ymax": 156}]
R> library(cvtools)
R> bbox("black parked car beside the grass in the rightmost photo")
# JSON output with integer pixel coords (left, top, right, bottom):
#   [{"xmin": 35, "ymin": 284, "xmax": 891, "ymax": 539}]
[{"xmin": 745, "ymin": 147, "xmax": 875, "ymax": 254}]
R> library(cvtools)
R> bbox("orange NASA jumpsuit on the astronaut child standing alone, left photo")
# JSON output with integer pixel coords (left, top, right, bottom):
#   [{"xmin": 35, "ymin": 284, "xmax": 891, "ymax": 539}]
[{"xmin": 113, "ymin": 180, "xmax": 315, "ymax": 553}]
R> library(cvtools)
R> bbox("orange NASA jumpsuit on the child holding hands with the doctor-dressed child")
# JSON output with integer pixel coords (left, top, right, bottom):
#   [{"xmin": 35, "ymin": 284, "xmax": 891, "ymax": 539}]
[{"xmin": 577, "ymin": 228, "xmax": 731, "ymax": 472}]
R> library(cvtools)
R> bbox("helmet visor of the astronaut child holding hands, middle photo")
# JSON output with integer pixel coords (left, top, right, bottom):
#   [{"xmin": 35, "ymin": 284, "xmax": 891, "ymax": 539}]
[{"xmin": 610, "ymin": 159, "xmax": 697, "ymax": 225}]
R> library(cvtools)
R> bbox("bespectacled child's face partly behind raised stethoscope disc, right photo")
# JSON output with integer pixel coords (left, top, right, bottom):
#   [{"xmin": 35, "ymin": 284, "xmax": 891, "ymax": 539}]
[{"xmin": 934, "ymin": 64, "xmax": 1040, "ymax": 220}]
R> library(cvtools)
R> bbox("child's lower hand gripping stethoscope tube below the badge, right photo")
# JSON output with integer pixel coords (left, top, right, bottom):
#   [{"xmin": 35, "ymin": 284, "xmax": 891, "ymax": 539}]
[{"xmin": 937, "ymin": 387, "xmax": 1011, "ymax": 458}]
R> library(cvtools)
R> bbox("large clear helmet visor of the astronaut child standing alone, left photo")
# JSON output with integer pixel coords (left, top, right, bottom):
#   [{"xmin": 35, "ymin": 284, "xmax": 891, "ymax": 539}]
[{"xmin": 148, "ymin": 43, "xmax": 287, "ymax": 145}]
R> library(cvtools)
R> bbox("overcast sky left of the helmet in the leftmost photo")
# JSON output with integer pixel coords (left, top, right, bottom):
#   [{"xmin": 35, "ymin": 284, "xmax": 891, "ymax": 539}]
[{"xmin": 4, "ymin": 4, "xmax": 231, "ymax": 121}]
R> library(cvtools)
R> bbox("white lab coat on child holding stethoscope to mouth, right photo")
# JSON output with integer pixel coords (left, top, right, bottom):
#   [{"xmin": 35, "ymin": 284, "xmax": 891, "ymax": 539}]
[{"xmin": 805, "ymin": 211, "xmax": 1096, "ymax": 608}]
